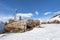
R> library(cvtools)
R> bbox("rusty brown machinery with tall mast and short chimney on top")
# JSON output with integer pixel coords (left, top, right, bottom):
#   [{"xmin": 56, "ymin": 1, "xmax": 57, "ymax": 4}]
[{"xmin": 4, "ymin": 10, "xmax": 40, "ymax": 32}]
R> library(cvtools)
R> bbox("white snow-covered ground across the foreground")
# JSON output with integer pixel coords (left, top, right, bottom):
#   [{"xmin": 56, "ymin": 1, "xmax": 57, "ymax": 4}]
[{"xmin": 0, "ymin": 24, "xmax": 60, "ymax": 40}]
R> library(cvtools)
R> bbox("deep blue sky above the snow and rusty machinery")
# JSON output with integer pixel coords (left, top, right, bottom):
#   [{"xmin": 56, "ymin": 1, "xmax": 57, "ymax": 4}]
[{"xmin": 0, "ymin": 0, "xmax": 60, "ymax": 19}]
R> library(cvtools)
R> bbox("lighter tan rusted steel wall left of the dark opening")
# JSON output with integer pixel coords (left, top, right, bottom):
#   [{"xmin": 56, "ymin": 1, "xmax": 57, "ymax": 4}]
[{"xmin": 5, "ymin": 22, "xmax": 26, "ymax": 31}]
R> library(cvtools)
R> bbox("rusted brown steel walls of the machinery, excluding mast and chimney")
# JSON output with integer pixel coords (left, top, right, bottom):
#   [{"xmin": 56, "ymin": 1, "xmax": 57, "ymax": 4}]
[{"xmin": 5, "ymin": 20, "xmax": 40, "ymax": 32}]
